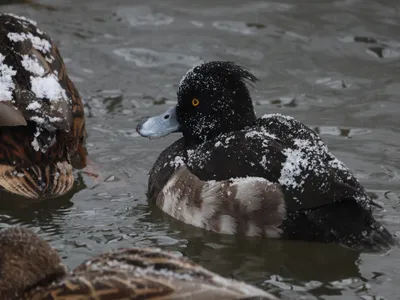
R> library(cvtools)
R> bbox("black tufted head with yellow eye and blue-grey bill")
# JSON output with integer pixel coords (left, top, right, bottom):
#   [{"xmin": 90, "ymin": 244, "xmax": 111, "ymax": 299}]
[{"xmin": 137, "ymin": 61, "xmax": 257, "ymax": 143}]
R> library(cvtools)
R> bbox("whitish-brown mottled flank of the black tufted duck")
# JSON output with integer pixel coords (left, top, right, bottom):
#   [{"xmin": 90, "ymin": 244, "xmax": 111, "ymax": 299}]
[{"xmin": 156, "ymin": 167, "xmax": 286, "ymax": 237}]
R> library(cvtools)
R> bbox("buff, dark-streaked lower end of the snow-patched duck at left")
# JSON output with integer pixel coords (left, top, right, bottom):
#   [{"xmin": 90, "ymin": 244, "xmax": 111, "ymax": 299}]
[{"xmin": 0, "ymin": 161, "xmax": 74, "ymax": 199}]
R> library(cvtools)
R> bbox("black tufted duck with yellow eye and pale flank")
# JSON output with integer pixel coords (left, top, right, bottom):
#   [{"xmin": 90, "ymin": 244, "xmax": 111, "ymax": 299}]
[{"xmin": 137, "ymin": 61, "xmax": 395, "ymax": 251}]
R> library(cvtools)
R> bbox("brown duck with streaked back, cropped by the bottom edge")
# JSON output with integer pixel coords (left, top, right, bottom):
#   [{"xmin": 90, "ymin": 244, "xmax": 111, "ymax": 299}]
[{"xmin": 0, "ymin": 227, "xmax": 278, "ymax": 300}]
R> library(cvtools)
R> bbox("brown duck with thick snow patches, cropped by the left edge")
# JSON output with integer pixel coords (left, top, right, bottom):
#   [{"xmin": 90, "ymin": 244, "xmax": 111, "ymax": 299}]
[{"xmin": 0, "ymin": 14, "xmax": 86, "ymax": 199}]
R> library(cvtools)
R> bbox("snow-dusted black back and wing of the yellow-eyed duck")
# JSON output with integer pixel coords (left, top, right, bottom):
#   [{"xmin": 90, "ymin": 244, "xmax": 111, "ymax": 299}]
[{"xmin": 166, "ymin": 114, "xmax": 371, "ymax": 211}]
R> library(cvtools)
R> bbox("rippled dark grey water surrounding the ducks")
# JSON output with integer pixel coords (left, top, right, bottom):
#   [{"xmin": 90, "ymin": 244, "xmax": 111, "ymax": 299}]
[{"xmin": 0, "ymin": 0, "xmax": 400, "ymax": 300}]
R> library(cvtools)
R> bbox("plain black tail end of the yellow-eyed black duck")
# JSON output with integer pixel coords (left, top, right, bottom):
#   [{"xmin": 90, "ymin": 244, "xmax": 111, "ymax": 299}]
[{"xmin": 283, "ymin": 199, "xmax": 397, "ymax": 252}]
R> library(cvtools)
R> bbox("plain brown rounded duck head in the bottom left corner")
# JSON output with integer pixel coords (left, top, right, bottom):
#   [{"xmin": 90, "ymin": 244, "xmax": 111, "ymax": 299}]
[{"xmin": 0, "ymin": 227, "xmax": 66, "ymax": 299}]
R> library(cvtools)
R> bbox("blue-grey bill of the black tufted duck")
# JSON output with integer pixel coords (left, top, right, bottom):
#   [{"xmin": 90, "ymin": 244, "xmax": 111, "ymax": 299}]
[{"xmin": 136, "ymin": 106, "xmax": 179, "ymax": 138}]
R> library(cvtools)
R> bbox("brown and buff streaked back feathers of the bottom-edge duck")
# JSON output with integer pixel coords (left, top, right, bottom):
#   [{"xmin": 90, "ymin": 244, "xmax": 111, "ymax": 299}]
[{"xmin": 26, "ymin": 248, "xmax": 276, "ymax": 300}]
